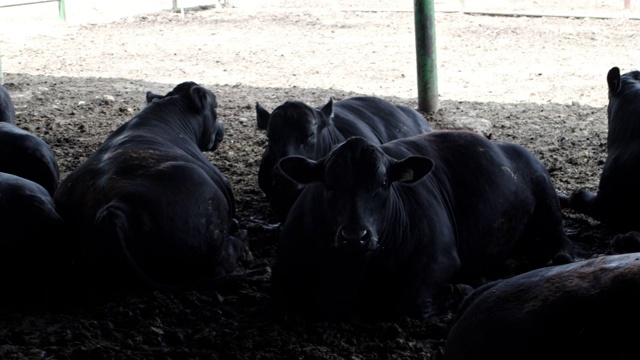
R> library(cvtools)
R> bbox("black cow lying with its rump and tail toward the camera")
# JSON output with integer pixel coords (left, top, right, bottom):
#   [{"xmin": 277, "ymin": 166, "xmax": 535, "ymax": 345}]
[{"xmin": 54, "ymin": 82, "xmax": 248, "ymax": 290}]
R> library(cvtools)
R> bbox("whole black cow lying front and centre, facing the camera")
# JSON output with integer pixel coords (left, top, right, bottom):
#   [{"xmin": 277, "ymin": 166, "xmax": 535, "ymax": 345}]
[{"xmin": 272, "ymin": 131, "xmax": 573, "ymax": 317}]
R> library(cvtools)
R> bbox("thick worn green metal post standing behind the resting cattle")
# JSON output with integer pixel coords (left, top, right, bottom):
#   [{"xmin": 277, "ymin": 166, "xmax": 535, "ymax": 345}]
[{"xmin": 414, "ymin": 0, "xmax": 438, "ymax": 112}]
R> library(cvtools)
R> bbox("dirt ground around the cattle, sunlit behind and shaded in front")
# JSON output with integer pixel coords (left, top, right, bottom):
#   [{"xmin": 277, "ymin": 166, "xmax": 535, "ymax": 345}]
[{"xmin": 0, "ymin": 1, "xmax": 640, "ymax": 359}]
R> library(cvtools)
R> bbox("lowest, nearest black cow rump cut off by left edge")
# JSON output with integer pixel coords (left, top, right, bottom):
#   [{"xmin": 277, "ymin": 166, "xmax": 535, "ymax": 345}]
[{"xmin": 0, "ymin": 172, "xmax": 68, "ymax": 304}]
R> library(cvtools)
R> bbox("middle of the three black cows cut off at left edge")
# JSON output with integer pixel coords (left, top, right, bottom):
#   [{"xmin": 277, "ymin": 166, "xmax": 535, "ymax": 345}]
[{"xmin": 0, "ymin": 122, "xmax": 60, "ymax": 196}]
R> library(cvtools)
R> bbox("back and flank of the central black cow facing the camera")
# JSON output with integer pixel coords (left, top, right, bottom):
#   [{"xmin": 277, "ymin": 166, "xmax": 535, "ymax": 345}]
[{"xmin": 381, "ymin": 131, "xmax": 570, "ymax": 276}]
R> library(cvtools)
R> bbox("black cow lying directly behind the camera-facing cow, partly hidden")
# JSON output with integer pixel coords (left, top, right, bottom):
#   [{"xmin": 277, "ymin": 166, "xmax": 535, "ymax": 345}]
[{"xmin": 256, "ymin": 96, "xmax": 431, "ymax": 220}]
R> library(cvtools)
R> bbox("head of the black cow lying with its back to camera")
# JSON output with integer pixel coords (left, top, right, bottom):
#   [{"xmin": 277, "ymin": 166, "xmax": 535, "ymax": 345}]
[{"xmin": 146, "ymin": 81, "xmax": 224, "ymax": 151}]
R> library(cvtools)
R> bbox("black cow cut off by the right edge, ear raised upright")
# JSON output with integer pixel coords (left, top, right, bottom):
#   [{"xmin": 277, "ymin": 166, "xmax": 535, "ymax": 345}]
[{"xmin": 560, "ymin": 67, "xmax": 640, "ymax": 230}]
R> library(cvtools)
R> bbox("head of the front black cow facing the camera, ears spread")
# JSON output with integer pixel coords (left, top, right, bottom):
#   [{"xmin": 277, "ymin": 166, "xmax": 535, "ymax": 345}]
[{"xmin": 279, "ymin": 137, "xmax": 433, "ymax": 251}]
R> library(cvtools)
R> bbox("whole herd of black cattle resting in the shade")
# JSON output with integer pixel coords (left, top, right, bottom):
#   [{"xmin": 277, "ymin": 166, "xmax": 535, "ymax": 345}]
[{"xmin": 0, "ymin": 67, "xmax": 640, "ymax": 359}]
